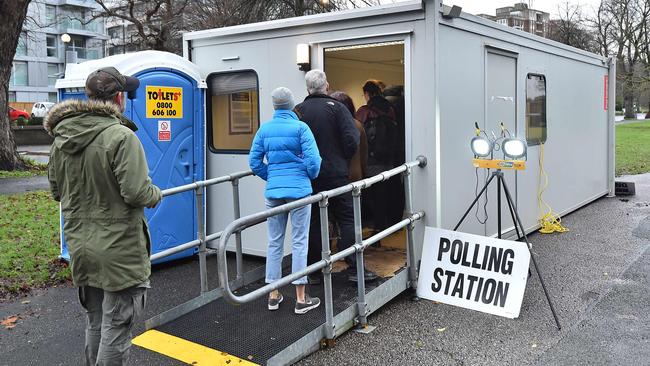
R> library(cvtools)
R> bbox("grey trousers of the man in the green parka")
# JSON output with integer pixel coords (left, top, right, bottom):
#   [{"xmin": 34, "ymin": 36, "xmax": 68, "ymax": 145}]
[{"xmin": 79, "ymin": 283, "xmax": 149, "ymax": 366}]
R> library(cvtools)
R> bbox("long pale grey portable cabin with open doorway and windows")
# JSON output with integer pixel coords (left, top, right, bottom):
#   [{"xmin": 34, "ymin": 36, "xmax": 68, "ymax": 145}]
[{"xmin": 184, "ymin": 0, "xmax": 615, "ymax": 255}]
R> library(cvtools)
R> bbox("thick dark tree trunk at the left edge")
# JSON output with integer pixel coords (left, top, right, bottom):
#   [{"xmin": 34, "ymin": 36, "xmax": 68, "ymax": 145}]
[{"xmin": 0, "ymin": 0, "xmax": 31, "ymax": 170}]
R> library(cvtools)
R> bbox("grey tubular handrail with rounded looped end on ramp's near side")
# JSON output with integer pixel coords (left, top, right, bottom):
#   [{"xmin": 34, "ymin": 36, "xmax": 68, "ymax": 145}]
[{"xmin": 217, "ymin": 156, "xmax": 426, "ymax": 306}]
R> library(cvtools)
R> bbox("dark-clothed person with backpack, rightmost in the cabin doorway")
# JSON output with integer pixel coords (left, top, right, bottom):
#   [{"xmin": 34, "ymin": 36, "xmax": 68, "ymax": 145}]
[{"xmin": 356, "ymin": 80, "xmax": 403, "ymax": 232}]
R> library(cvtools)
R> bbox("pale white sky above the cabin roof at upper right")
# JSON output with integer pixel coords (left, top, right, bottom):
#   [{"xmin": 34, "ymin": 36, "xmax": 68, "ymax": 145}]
[{"xmin": 443, "ymin": 0, "xmax": 600, "ymax": 18}]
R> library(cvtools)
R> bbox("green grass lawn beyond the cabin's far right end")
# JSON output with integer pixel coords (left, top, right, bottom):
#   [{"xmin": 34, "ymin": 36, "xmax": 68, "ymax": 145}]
[{"xmin": 616, "ymin": 120, "xmax": 650, "ymax": 176}]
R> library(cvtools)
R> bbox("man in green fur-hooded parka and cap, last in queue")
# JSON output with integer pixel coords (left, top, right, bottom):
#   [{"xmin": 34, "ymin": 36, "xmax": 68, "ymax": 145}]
[{"xmin": 43, "ymin": 67, "xmax": 162, "ymax": 365}]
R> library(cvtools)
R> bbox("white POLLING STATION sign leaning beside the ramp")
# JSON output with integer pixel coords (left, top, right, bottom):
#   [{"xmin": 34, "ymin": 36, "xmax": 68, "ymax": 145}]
[{"xmin": 417, "ymin": 227, "xmax": 530, "ymax": 318}]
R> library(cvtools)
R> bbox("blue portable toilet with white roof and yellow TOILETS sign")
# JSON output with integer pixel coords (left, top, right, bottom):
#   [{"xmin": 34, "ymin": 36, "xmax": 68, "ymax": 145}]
[{"xmin": 55, "ymin": 51, "xmax": 206, "ymax": 262}]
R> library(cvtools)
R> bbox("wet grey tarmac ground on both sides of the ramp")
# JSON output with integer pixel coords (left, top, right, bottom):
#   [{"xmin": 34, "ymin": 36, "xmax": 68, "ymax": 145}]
[{"xmin": 0, "ymin": 174, "xmax": 650, "ymax": 365}]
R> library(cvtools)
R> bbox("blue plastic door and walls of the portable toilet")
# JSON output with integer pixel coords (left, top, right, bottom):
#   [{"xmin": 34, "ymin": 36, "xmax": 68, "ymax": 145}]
[{"xmin": 60, "ymin": 69, "xmax": 204, "ymax": 263}]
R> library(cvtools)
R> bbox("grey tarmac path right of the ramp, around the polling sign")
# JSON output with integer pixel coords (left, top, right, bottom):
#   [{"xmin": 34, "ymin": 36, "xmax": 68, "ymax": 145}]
[{"xmin": 299, "ymin": 174, "xmax": 650, "ymax": 366}]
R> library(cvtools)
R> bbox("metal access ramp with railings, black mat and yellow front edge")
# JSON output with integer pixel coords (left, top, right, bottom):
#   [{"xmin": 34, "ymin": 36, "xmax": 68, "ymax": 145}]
[{"xmin": 133, "ymin": 158, "xmax": 426, "ymax": 365}]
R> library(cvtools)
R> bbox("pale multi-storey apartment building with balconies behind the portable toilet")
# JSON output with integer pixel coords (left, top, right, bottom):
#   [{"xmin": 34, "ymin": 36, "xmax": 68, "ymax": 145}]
[{"xmin": 9, "ymin": 0, "xmax": 108, "ymax": 102}]
